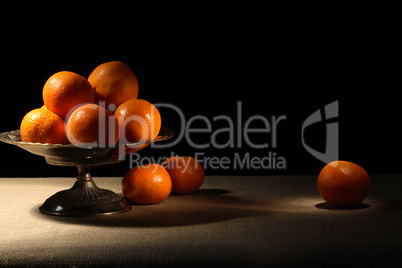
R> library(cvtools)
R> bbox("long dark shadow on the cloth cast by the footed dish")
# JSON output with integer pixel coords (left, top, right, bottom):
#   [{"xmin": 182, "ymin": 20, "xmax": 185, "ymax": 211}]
[{"xmin": 30, "ymin": 189, "xmax": 267, "ymax": 227}]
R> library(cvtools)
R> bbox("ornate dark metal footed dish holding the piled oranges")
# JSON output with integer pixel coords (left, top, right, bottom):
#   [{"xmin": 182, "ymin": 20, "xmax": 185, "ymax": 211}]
[{"xmin": 0, "ymin": 128, "xmax": 174, "ymax": 216}]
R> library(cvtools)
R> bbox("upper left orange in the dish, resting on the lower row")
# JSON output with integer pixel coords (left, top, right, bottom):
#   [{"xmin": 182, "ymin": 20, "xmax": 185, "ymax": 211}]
[{"xmin": 42, "ymin": 71, "xmax": 95, "ymax": 119}]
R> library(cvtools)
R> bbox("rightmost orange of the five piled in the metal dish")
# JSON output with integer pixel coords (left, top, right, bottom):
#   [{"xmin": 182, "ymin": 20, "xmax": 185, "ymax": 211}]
[{"xmin": 114, "ymin": 99, "xmax": 161, "ymax": 143}]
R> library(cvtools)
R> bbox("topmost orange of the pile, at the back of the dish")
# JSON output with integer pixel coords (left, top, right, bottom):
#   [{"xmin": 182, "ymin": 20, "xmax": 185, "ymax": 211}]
[{"xmin": 88, "ymin": 61, "xmax": 138, "ymax": 111}]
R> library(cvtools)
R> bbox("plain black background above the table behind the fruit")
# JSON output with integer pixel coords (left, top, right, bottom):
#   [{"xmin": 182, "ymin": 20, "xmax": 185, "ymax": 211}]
[{"xmin": 0, "ymin": 1, "xmax": 402, "ymax": 177}]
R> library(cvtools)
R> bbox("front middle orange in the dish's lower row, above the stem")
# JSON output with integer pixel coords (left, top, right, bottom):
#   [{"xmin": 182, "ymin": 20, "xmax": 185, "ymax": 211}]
[{"xmin": 66, "ymin": 104, "xmax": 119, "ymax": 146}]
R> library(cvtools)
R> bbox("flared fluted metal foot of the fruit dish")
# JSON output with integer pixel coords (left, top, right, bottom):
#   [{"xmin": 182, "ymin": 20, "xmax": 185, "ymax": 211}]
[{"xmin": 39, "ymin": 178, "xmax": 131, "ymax": 216}]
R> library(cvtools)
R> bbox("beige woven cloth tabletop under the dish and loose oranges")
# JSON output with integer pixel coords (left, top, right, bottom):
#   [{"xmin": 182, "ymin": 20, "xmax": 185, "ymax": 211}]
[{"xmin": 0, "ymin": 174, "xmax": 402, "ymax": 267}]
